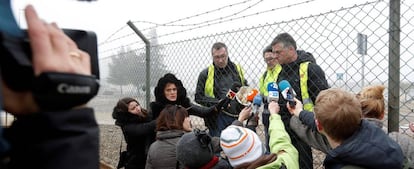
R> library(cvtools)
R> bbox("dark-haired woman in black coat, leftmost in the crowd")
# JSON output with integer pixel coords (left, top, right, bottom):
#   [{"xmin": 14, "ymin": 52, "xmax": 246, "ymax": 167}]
[{"xmin": 112, "ymin": 97, "xmax": 156, "ymax": 169}]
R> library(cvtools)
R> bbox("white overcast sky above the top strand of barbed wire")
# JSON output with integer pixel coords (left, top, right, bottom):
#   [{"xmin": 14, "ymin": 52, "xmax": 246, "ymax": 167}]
[{"xmin": 12, "ymin": 0, "xmax": 362, "ymax": 42}]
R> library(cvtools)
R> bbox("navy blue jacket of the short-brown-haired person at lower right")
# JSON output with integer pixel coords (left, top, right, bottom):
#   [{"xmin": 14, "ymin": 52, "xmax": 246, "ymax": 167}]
[{"xmin": 324, "ymin": 120, "xmax": 404, "ymax": 169}]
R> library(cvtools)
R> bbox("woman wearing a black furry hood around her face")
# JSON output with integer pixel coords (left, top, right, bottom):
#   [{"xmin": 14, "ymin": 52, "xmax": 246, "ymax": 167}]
[{"xmin": 150, "ymin": 73, "xmax": 224, "ymax": 121}]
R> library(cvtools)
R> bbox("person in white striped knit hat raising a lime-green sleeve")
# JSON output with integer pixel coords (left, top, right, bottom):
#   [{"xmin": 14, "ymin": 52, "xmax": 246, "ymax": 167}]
[{"xmin": 220, "ymin": 102, "xmax": 299, "ymax": 169}]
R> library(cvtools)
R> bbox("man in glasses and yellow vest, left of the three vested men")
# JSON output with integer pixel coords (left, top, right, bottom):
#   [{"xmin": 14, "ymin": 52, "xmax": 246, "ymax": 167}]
[{"xmin": 195, "ymin": 42, "xmax": 247, "ymax": 137}]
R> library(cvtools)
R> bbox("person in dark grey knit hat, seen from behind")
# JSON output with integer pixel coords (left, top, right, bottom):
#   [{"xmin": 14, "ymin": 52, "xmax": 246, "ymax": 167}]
[{"xmin": 177, "ymin": 129, "xmax": 232, "ymax": 169}]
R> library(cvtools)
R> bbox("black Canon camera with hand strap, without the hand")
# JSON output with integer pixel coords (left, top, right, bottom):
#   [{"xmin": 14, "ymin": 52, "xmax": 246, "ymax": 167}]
[{"xmin": 0, "ymin": 29, "xmax": 99, "ymax": 110}]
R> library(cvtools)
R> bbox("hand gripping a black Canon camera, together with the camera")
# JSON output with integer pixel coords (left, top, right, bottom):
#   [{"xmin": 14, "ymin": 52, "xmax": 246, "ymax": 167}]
[{"xmin": 0, "ymin": 5, "xmax": 99, "ymax": 115}]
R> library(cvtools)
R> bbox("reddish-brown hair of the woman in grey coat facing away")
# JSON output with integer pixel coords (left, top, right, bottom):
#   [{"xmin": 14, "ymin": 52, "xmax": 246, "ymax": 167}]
[{"xmin": 155, "ymin": 104, "xmax": 188, "ymax": 131}]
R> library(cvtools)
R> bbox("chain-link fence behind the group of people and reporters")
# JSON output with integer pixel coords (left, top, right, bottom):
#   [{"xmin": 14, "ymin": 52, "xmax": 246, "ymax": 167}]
[{"xmin": 90, "ymin": 0, "xmax": 414, "ymax": 168}]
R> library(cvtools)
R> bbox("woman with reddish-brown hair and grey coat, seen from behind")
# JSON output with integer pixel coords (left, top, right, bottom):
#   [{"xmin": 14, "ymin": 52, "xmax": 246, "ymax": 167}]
[{"xmin": 145, "ymin": 105, "xmax": 192, "ymax": 169}]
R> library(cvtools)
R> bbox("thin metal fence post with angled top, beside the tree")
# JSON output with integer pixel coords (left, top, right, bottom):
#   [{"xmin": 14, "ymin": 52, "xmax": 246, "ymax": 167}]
[{"xmin": 127, "ymin": 21, "xmax": 151, "ymax": 108}]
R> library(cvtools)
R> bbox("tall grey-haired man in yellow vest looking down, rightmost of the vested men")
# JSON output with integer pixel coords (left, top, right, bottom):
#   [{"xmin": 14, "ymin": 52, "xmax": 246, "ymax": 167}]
[{"xmin": 271, "ymin": 33, "xmax": 329, "ymax": 169}]
